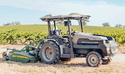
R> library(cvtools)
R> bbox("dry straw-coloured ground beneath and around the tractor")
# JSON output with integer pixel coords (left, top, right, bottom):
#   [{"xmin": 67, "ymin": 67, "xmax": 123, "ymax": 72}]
[{"xmin": 0, "ymin": 45, "xmax": 125, "ymax": 74}]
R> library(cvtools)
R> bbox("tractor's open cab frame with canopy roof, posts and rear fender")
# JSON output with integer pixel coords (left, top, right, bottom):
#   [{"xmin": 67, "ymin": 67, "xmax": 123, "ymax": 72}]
[{"xmin": 41, "ymin": 13, "xmax": 90, "ymax": 58}]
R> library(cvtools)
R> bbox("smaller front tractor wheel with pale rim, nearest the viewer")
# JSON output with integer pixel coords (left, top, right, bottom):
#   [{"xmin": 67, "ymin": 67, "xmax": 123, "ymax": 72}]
[{"xmin": 86, "ymin": 51, "xmax": 102, "ymax": 67}]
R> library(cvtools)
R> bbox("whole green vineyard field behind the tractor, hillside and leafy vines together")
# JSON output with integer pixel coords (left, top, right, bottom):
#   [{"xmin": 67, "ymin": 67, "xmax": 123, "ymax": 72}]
[{"xmin": 0, "ymin": 25, "xmax": 125, "ymax": 44}]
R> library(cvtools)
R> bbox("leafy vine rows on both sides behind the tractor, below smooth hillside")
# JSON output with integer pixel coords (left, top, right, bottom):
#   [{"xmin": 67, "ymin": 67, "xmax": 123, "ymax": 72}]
[{"xmin": 0, "ymin": 29, "xmax": 125, "ymax": 45}]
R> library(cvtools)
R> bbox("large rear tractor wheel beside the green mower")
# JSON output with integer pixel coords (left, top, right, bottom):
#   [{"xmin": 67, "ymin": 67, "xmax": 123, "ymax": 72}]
[{"xmin": 39, "ymin": 41, "xmax": 60, "ymax": 64}]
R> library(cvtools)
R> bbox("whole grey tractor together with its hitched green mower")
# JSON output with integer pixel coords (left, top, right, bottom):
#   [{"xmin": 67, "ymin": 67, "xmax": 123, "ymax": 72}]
[{"xmin": 2, "ymin": 13, "xmax": 118, "ymax": 67}]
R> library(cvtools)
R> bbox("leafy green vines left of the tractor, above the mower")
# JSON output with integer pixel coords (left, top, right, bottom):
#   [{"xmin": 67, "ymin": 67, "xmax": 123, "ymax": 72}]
[{"xmin": 0, "ymin": 29, "xmax": 48, "ymax": 44}]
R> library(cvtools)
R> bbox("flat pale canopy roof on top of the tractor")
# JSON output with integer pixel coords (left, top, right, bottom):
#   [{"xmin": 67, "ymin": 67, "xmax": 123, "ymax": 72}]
[{"xmin": 40, "ymin": 13, "xmax": 91, "ymax": 22}]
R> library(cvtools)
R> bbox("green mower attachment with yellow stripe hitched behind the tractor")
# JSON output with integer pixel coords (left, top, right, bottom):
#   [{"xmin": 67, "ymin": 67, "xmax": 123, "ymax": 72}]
[{"xmin": 3, "ymin": 40, "xmax": 44, "ymax": 63}]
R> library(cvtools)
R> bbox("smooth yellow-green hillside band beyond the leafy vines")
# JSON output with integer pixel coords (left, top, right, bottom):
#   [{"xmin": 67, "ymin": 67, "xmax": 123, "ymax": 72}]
[{"xmin": 0, "ymin": 25, "xmax": 125, "ymax": 33}]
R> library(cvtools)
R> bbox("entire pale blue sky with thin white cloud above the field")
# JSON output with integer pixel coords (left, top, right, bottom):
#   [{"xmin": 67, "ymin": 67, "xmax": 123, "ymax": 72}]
[{"xmin": 0, "ymin": 0, "xmax": 125, "ymax": 26}]
